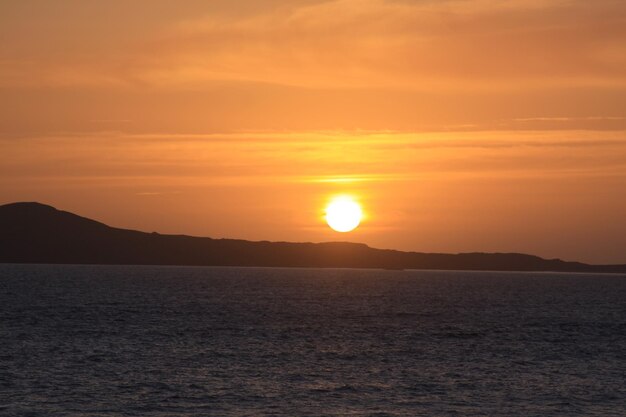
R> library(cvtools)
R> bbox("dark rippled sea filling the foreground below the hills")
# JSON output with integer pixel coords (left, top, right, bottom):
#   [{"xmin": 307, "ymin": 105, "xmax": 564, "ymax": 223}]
[{"xmin": 0, "ymin": 264, "xmax": 626, "ymax": 417}]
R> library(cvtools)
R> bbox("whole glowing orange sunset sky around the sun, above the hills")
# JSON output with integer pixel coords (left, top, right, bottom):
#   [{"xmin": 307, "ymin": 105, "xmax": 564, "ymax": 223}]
[{"xmin": 0, "ymin": 0, "xmax": 626, "ymax": 263}]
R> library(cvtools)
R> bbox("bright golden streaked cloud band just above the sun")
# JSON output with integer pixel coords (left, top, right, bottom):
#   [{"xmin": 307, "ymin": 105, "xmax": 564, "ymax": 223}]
[{"xmin": 0, "ymin": 132, "xmax": 626, "ymax": 186}]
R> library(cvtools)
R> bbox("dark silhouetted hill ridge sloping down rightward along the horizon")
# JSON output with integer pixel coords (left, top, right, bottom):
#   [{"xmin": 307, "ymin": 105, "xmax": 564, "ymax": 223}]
[{"xmin": 0, "ymin": 203, "xmax": 626, "ymax": 273}]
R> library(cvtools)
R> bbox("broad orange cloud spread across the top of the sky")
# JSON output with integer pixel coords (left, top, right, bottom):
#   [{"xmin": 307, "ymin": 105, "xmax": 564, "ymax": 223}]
[{"xmin": 3, "ymin": 0, "xmax": 626, "ymax": 91}]
